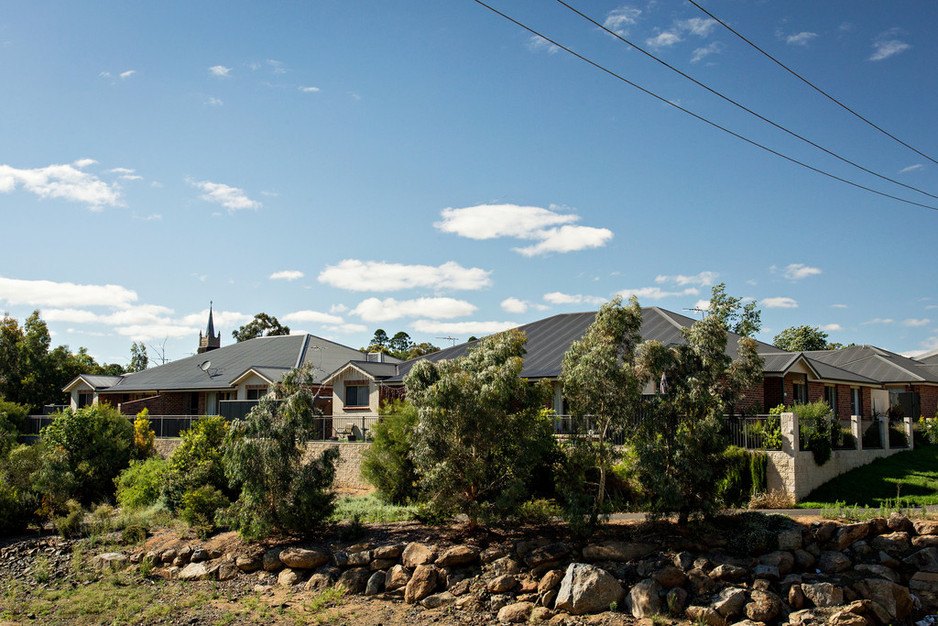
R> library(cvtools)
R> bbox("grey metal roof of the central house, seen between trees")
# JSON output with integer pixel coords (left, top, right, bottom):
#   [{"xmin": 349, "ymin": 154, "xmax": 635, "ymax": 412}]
[{"xmin": 389, "ymin": 307, "xmax": 779, "ymax": 382}]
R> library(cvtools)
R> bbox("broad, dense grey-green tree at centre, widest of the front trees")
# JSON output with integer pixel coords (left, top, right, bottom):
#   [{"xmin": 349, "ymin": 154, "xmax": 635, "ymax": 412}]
[{"xmin": 404, "ymin": 331, "xmax": 553, "ymax": 526}]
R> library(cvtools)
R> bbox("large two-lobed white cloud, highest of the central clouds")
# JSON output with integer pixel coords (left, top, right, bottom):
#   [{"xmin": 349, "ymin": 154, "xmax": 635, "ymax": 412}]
[{"xmin": 434, "ymin": 204, "xmax": 613, "ymax": 256}]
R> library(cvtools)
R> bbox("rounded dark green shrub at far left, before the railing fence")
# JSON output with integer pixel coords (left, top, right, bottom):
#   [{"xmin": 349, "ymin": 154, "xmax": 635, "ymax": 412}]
[{"xmin": 36, "ymin": 404, "xmax": 134, "ymax": 511}]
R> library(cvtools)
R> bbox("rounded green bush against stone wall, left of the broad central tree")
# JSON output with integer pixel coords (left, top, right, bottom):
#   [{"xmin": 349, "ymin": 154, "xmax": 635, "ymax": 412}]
[{"xmin": 361, "ymin": 400, "xmax": 418, "ymax": 504}]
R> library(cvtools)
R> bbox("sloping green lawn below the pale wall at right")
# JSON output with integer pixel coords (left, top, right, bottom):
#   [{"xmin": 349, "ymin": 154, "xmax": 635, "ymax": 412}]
[{"xmin": 798, "ymin": 446, "xmax": 938, "ymax": 508}]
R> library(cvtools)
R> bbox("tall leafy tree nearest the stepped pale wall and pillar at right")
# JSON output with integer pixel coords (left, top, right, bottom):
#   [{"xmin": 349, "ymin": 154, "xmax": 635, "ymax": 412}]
[{"xmin": 629, "ymin": 289, "xmax": 762, "ymax": 524}]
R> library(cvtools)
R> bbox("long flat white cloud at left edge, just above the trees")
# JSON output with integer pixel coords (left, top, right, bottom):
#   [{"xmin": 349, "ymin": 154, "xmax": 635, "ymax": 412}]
[{"xmin": 0, "ymin": 276, "xmax": 137, "ymax": 307}]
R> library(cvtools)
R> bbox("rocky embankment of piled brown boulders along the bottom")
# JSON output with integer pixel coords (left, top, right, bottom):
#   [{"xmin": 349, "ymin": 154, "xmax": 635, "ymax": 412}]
[{"xmin": 86, "ymin": 514, "xmax": 938, "ymax": 626}]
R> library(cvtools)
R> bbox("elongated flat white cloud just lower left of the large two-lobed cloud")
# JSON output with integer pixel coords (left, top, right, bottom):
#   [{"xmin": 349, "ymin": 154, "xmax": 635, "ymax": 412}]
[{"xmin": 318, "ymin": 259, "xmax": 492, "ymax": 291}]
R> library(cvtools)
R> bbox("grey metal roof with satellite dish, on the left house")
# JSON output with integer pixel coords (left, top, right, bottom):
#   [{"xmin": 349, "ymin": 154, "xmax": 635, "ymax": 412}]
[{"xmin": 96, "ymin": 334, "xmax": 388, "ymax": 393}]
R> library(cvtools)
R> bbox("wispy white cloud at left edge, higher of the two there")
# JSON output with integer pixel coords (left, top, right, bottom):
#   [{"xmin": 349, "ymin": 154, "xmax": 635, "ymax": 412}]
[{"xmin": 0, "ymin": 159, "xmax": 121, "ymax": 211}]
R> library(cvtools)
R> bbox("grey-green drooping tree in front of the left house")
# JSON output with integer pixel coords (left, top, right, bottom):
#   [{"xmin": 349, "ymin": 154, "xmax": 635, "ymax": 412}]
[{"xmin": 223, "ymin": 365, "xmax": 339, "ymax": 537}]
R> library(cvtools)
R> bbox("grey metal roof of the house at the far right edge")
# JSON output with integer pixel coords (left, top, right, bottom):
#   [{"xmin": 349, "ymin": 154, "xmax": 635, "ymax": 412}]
[{"xmin": 805, "ymin": 346, "xmax": 938, "ymax": 384}]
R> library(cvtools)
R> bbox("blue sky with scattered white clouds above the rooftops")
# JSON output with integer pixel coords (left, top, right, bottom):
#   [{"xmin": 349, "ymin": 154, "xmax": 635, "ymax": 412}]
[{"xmin": 0, "ymin": 0, "xmax": 938, "ymax": 363}]
